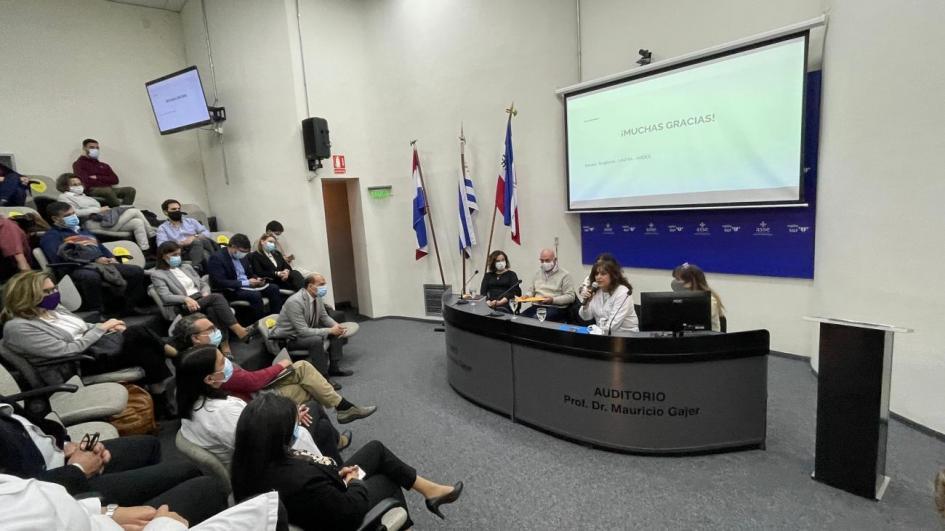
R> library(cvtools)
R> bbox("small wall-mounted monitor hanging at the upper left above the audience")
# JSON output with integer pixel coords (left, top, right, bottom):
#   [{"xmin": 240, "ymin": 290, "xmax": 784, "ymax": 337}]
[{"xmin": 145, "ymin": 66, "xmax": 211, "ymax": 135}]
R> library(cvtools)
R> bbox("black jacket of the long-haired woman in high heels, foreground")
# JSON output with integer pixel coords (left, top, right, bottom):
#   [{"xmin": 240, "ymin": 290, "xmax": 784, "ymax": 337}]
[{"xmin": 256, "ymin": 458, "xmax": 371, "ymax": 531}]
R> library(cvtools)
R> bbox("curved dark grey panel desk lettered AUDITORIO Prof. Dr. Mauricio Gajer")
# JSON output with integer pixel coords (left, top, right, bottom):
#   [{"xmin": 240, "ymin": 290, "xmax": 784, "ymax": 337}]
[{"xmin": 443, "ymin": 294, "xmax": 769, "ymax": 454}]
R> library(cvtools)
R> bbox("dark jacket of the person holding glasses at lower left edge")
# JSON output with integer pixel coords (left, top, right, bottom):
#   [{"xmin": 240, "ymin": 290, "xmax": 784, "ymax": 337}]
[{"xmin": 0, "ymin": 411, "xmax": 92, "ymax": 494}]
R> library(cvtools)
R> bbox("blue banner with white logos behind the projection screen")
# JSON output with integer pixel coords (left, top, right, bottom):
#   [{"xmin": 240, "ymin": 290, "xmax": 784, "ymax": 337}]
[{"xmin": 581, "ymin": 71, "xmax": 821, "ymax": 278}]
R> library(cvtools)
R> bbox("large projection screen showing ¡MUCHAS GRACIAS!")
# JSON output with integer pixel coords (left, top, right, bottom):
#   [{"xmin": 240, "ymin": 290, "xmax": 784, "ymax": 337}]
[{"xmin": 565, "ymin": 32, "xmax": 808, "ymax": 211}]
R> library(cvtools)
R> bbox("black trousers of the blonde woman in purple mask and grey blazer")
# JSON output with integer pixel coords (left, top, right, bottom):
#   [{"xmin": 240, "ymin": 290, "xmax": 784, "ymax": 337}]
[{"xmin": 82, "ymin": 326, "xmax": 171, "ymax": 384}]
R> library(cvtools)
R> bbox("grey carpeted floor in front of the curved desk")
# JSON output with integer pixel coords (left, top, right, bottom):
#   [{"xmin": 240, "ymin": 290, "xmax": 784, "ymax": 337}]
[{"xmin": 162, "ymin": 319, "xmax": 945, "ymax": 530}]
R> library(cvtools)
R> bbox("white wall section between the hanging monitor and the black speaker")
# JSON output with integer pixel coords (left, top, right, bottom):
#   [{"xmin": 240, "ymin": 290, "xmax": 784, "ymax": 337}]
[{"xmin": 181, "ymin": 0, "xmax": 331, "ymax": 304}]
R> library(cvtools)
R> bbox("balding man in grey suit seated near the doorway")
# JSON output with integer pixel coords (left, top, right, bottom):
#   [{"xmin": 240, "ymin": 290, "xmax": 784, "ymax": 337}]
[{"xmin": 269, "ymin": 273, "xmax": 357, "ymax": 378}]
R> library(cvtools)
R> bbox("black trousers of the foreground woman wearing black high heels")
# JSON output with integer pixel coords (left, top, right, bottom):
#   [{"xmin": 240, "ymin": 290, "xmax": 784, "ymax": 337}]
[{"xmin": 345, "ymin": 441, "xmax": 417, "ymax": 527}]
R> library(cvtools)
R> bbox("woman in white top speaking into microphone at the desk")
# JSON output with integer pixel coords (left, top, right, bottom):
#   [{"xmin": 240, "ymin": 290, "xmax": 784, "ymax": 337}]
[{"xmin": 579, "ymin": 260, "xmax": 640, "ymax": 335}]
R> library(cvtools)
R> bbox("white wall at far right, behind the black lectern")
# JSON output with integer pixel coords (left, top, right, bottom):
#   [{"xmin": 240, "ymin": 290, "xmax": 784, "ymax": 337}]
[{"xmin": 812, "ymin": 0, "xmax": 945, "ymax": 432}]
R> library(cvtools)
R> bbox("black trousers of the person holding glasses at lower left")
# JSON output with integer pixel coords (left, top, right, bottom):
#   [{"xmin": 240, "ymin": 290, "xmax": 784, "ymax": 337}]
[{"xmin": 89, "ymin": 435, "xmax": 227, "ymax": 525}]
